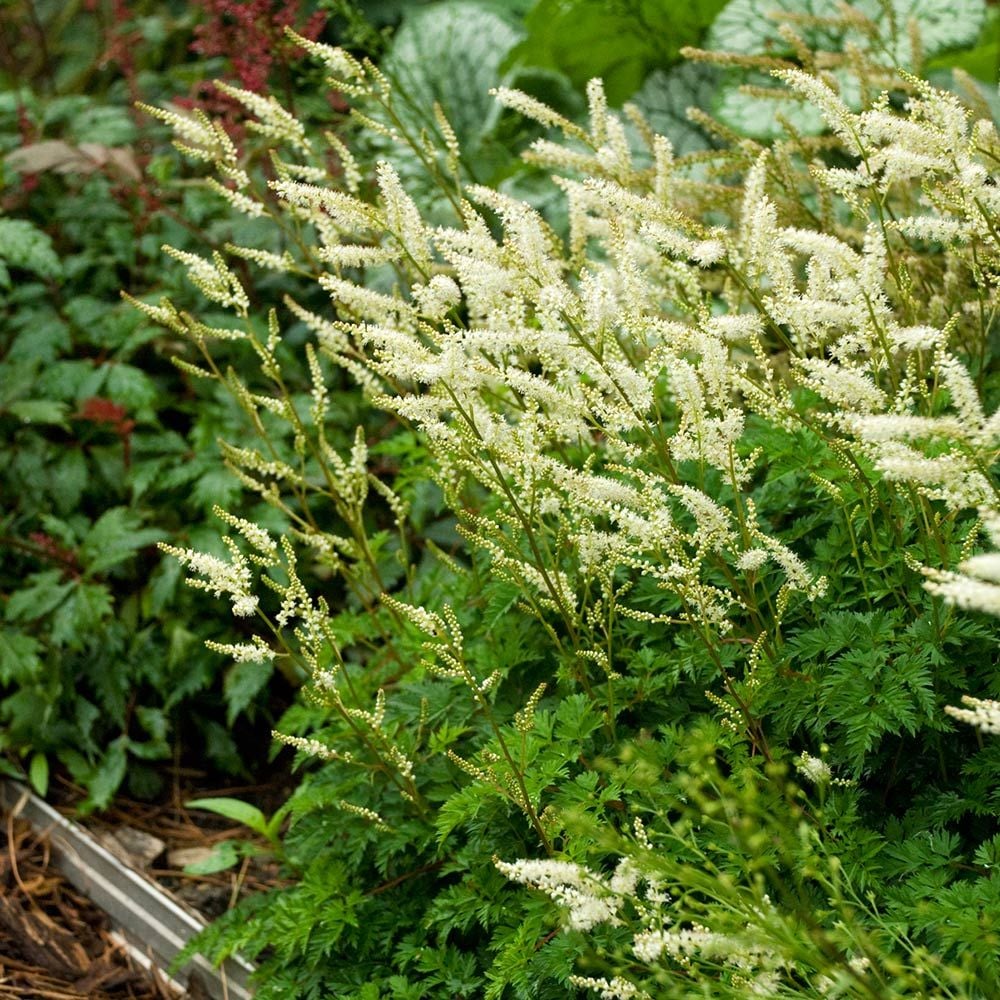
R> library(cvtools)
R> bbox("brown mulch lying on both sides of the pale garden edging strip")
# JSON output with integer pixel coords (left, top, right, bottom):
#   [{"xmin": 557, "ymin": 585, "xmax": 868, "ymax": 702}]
[{"xmin": 0, "ymin": 773, "xmax": 290, "ymax": 1000}]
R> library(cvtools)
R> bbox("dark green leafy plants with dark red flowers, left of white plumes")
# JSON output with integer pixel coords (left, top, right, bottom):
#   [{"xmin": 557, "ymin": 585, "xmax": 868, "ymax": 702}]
[{"xmin": 0, "ymin": 2, "xmax": 344, "ymax": 808}]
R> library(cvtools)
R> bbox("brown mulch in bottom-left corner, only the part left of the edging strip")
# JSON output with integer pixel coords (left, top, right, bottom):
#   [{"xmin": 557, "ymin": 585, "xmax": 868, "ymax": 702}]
[{"xmin": 0, "ymin": 814, "xmax": 176, "ymax": 1000}]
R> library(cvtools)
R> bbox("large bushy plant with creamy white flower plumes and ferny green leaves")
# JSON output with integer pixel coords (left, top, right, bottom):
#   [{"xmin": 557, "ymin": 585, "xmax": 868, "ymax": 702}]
[{"xmin": 127, "ymin": 0, "xmax": 1000, "ymax": 998}]
